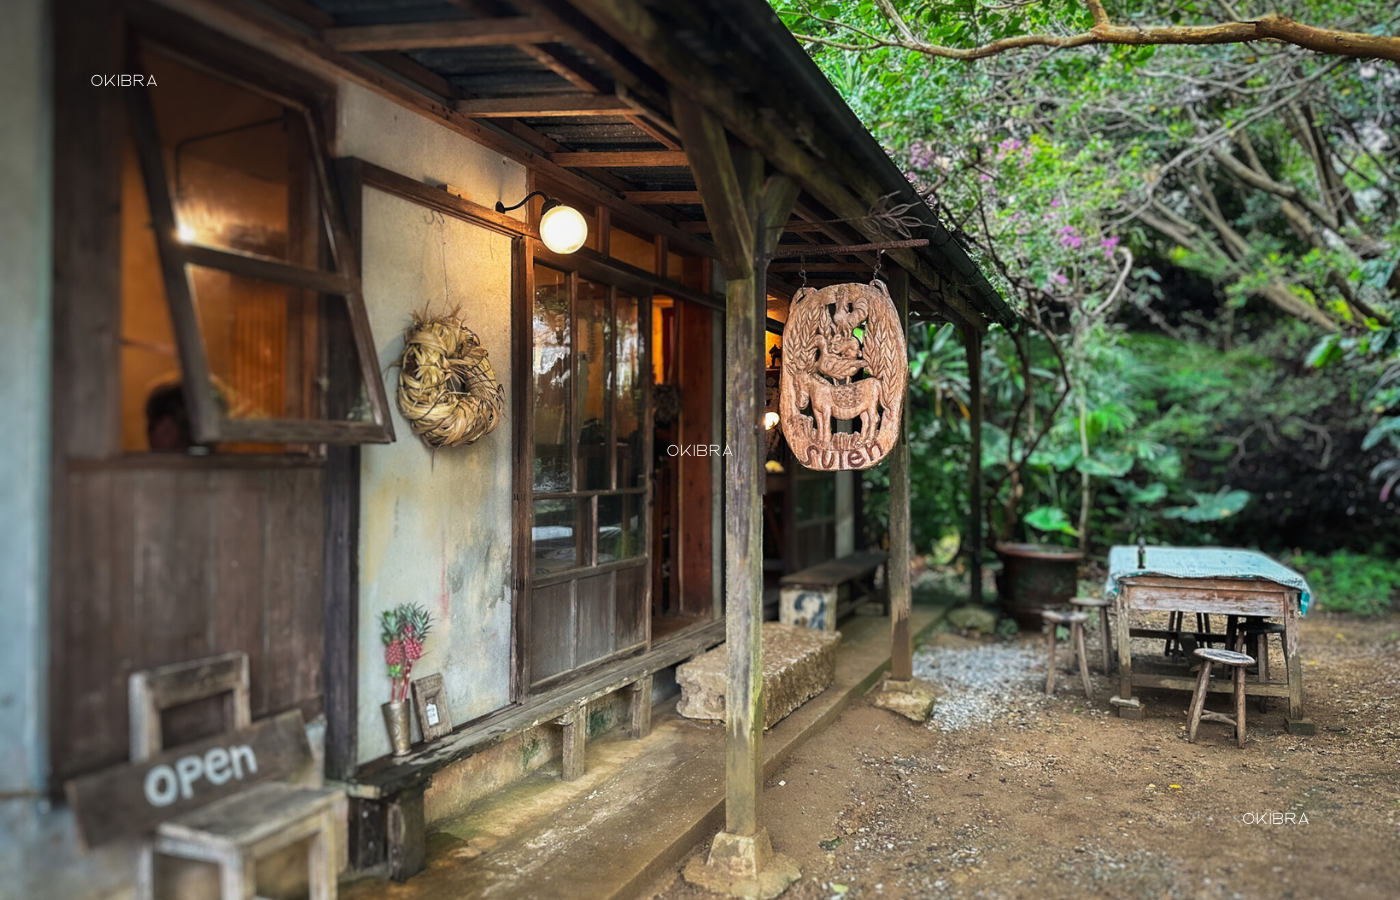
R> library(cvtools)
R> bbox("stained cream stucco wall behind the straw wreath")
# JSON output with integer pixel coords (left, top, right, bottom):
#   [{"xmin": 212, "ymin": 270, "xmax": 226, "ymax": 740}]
[{"xmin": 340, "ymin": 87, "xmax": 525, "ymax": 761}]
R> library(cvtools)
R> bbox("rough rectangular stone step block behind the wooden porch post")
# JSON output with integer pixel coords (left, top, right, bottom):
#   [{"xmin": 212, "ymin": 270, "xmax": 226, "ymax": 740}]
[{"xmin": 676, "ymin": 621, "xmax": 841, "ymax": 729}]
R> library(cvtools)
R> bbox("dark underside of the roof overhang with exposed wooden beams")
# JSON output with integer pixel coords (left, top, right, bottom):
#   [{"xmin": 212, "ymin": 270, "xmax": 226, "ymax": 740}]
[{"xmin": 197, "ymin": 0, "xmax": 1012, "ymax": 332}]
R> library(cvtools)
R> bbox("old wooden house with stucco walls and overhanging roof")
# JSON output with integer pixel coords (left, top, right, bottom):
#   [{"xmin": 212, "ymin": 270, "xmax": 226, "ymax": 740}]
[{"xmin": 0, "ymin": 0, "xmax": 1007, "ymax": 897}]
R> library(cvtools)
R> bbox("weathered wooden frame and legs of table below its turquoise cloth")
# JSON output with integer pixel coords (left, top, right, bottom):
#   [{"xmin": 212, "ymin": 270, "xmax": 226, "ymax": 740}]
[{"xmin": 1113, "ymin": 548, "xmax": 1312, "ymax": 733}]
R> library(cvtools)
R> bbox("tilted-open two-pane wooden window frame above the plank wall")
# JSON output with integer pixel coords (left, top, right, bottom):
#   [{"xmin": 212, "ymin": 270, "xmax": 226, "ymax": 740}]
[{"xmin": 127, "ymin": 25, "xmax": 395, "ymax": 444}]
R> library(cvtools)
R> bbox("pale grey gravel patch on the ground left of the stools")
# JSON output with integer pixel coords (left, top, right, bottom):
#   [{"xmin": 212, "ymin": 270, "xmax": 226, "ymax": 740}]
[{"xmin": 914, "ymin": 644, "xmax": 1046, "ymax": 731}]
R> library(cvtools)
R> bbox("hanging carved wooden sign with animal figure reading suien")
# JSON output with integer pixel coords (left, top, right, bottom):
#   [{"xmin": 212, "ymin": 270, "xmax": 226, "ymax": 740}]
[{"xmin": 778, "ymin": 281, "xmax": 909, "ymax": 472}]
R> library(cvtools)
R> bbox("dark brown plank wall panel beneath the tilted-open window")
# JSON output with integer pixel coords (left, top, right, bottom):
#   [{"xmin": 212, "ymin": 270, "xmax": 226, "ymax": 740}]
[{"xmin": 50, "ymin": 458, "xmax": 323, "ymax": 781}]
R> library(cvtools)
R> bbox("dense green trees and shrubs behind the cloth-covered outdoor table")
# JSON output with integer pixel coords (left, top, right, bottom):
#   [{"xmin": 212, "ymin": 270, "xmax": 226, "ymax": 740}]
[{"xmin": 773, "ymin": 0, "xmax": 1400, "ymax": 551}]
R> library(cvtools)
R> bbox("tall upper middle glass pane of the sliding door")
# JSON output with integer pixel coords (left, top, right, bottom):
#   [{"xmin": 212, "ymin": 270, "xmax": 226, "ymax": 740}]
[{"xmin": 574, "ymin": 279, "xmax": 613, "ymax": 491}]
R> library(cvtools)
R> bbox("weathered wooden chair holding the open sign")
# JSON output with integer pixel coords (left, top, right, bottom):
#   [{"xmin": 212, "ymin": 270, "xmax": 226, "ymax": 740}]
[{"xmin": 127, "ymin": 652, "xmax": 344, "ymax": 900}]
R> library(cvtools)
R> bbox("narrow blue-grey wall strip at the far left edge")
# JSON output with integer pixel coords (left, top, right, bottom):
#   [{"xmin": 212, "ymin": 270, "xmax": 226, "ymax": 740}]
[{"xmin": 0, "ymin": 0, "xmax": 129, "ymax": 900}]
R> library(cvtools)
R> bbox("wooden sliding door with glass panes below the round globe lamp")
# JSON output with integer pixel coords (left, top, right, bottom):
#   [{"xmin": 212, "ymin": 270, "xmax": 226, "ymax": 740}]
[{"xmin": 517, "ymin": 262, "xmax": 652, "ymax": 693}]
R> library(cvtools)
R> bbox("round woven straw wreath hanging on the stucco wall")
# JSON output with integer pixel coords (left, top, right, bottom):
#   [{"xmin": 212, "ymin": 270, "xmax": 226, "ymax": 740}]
[{"xmin": 398, "ymin": 309, "xmax": 505, "ymax": 448}]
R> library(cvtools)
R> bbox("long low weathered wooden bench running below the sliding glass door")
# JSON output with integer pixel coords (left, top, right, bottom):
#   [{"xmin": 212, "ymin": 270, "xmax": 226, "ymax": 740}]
[{"xmin": 346, "ymin": 620, "xmax": 724, "ymax": 882}]
